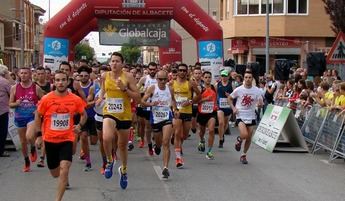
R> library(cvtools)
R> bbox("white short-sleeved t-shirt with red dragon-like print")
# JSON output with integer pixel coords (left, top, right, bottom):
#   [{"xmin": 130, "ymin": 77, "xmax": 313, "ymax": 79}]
[{"xmin": 230, "ymin": 85, "xmax": 262, "ymax": 120}]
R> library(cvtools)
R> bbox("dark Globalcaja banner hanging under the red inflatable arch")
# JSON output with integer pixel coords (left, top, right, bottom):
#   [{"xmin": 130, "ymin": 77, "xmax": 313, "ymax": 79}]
[{"xmin": 98, "ymin": 19, "xmax": 170, "ymax": 47}]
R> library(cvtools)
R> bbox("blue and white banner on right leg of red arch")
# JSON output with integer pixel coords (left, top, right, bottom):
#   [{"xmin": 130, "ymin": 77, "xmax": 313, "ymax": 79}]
[{"xmin": 198, "ymin": 41, "xmax": 223, "ymax": 81}]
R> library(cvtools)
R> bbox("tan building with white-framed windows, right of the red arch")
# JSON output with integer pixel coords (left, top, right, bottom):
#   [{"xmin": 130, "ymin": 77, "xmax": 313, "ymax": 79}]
[{"xmin": 220, "ymin": 0, "xmax": 335, "ymax": 72}]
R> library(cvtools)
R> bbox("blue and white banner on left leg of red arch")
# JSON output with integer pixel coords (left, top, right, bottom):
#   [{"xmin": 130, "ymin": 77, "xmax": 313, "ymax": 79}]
[{"xmin": 43, "ymin": 37, "xmax": 69, "ymax": 72}]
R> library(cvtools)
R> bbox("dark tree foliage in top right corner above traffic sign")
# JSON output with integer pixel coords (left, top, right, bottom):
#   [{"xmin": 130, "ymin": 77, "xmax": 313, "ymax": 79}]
[{"xmin": 322, "ymin": 0, "xmax": 345, "ymax": 34}]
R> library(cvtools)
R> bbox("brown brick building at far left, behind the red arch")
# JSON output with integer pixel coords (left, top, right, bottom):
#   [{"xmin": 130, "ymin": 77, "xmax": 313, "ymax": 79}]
[{"xmin": 0, "ymin": 0, "xmax": 45, "ymax": 69}]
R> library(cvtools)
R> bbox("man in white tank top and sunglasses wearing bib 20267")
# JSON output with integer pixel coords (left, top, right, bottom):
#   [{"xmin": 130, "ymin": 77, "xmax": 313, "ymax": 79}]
[{"xmin": 142, "ymin": 70, "xmax": 176, "ymax": 179}]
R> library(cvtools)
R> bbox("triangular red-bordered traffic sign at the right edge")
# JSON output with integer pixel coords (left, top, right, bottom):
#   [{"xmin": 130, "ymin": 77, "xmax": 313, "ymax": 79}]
[{"xmin": 327, "ymin": 32, "xmax": 345, "ymax": 64}]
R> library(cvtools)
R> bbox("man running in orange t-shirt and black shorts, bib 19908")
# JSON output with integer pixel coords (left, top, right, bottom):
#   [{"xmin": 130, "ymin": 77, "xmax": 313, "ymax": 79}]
[{"xmin": 35, "ymin": 71, "xmax": 87, "ymax": 201}]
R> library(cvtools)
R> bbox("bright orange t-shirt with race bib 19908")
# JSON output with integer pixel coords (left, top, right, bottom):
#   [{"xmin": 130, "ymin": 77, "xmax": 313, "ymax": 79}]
[{"xmin": 37, "ymin": 91, "xmax": 86, "ymax": 143}]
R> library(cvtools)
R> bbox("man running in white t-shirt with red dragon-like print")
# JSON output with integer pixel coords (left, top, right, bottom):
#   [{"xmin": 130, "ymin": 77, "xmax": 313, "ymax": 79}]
[{"xmin": 229, "ymin": 69, "xmax": 263, "ymax": 164}]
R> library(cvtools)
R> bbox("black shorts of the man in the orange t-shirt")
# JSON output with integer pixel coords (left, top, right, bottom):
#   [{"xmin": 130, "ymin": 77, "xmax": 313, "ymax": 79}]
[{"xmin": 44, "ymin": 141, "xmax": 73, "ymax": 170}]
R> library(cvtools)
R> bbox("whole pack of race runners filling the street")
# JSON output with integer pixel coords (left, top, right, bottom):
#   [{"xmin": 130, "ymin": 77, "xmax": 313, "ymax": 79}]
[{"xmin": 4, "ymin": 52, "xmax": 263, "ymax": 200}]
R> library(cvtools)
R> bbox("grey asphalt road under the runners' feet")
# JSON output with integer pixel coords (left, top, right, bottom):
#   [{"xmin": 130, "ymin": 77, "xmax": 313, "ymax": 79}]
[{"xmin": 0, "ymin": 128, "xmax": 345, "ymax": 201}]
